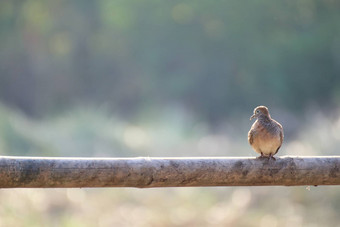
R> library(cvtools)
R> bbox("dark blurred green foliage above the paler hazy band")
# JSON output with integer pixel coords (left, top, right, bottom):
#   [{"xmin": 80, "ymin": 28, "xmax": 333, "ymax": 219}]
[{"xmin": 0, "ymin": 0, "xmax": 340, "ymax": 122}]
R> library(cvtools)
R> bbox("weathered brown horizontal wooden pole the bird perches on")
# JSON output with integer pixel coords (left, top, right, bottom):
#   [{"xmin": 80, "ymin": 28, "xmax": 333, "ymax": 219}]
[{"xmin": 0, "ymin": 156, "xmax": 340, "ymax": 188}]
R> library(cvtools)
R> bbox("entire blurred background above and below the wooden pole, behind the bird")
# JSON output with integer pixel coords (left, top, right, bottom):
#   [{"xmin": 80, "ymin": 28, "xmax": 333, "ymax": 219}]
[{"xmin": 0, "ymin": 0, "xmax": 340, "ymax": 227}]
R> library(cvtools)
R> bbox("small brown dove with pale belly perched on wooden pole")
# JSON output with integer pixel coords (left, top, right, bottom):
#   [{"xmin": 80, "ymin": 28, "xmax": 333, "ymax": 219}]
[{"xmin": 248, "ymin": 106, "xmax": 284, "ymax": 160}]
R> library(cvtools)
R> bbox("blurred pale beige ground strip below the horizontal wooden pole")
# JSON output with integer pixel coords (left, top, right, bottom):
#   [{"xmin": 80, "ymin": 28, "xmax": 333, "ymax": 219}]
[{"xmin": 0, "ymin": 186, "xmax": 340, "ymax": 227}]
